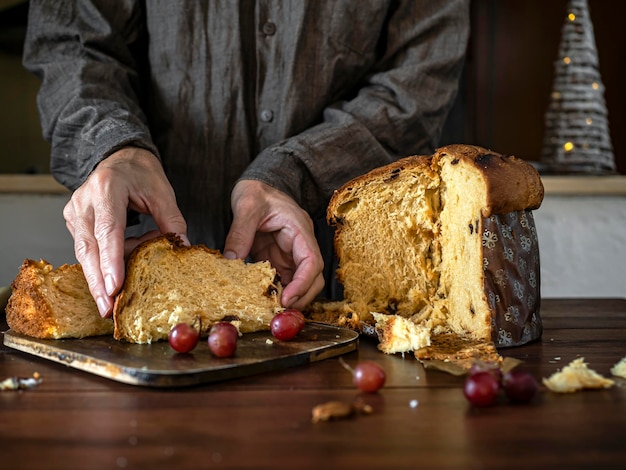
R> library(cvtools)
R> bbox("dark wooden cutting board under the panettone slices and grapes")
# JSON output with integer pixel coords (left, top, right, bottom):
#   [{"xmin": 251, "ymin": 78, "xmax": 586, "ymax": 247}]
[{"xmin": 4, "ymin": 323, "xmax": 358, "ymax": 387}]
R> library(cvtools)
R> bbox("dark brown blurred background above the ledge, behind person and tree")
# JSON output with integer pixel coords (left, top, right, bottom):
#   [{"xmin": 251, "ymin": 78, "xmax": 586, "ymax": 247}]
[{"xmin": 0, "ymin": 0, "xmax": 626, "ymax": 174}]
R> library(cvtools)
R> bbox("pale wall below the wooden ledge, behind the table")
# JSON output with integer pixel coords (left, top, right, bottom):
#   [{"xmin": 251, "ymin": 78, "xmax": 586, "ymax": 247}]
[{"xmin": 0, "ymin": 194, "xmax": 626, "ymax": 298}]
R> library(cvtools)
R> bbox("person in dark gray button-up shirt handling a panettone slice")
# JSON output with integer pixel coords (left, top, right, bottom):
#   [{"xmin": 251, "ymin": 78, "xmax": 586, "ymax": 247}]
[{"xmin": 24, "ymin": 0, "xmax": 469, "ymax": 316}]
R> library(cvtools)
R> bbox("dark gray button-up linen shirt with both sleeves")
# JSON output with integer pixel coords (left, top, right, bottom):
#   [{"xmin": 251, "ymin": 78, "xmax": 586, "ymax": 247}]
[{"xmin": 24, "ymin": 0, "xmax": 469, "ymax": 292}]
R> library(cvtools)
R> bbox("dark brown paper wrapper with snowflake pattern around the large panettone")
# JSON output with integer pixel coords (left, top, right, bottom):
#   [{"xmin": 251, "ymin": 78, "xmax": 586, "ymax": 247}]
[{"xmin": 482, "ymin": 210, "xmax": 543, "ymax": 348}]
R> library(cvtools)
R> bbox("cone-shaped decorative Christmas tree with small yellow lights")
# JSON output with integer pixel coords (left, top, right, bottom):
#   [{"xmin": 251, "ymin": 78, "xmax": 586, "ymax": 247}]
[{"xmin": 541, "ymin": 0, "xmax": 616, "ymax": 174}]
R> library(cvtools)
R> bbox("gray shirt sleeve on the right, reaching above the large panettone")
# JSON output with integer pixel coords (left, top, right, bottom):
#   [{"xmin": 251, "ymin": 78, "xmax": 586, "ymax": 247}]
[{"xmin": 241, "ymin": 0, "xmax": 469, "ymax": 217}]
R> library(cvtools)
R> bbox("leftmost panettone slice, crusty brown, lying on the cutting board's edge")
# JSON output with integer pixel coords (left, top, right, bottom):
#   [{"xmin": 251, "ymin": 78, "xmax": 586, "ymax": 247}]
[{"xmin": 6, "ymin": 259, "xmax": 113, "ymax": 339}]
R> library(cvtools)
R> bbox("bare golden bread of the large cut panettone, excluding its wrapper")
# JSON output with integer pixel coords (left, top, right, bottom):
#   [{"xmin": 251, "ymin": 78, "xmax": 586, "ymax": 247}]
[{"xmin": 320, "ymin": 145, "xmax": 543, "ymax": 352}]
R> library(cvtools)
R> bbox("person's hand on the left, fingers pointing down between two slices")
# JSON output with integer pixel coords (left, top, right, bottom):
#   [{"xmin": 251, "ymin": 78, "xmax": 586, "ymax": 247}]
[{"xmin": 63, "ymin": 147, "xmax": 187, "ymax": 317}]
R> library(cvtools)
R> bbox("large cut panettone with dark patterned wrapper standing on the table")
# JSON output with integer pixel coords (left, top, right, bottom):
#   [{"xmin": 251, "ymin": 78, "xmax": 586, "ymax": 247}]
[{"xmin": 312, "ymin": 145, "xmax": 543, "ymax": 357}]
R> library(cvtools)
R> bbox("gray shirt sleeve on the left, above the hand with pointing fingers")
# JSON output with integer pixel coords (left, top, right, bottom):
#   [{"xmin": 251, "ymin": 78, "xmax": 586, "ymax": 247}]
[{"xmin": 23, "ymin": 0, "xmax": 158, "ymax": 189}]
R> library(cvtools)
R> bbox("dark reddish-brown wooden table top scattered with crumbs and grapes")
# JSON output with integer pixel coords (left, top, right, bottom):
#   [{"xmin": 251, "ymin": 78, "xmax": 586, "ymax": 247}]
[{"xmin": 0, "ymin": 300, "xmax": 626, "ymax": 470}]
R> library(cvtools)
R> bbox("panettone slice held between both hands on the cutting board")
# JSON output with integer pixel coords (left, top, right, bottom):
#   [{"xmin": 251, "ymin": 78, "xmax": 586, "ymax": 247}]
[{"xmin": 113, "ymin": 234, "xmax": 282, "ymax": 343}]
